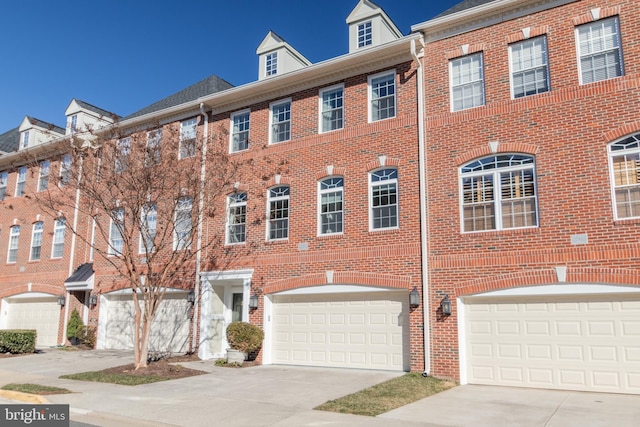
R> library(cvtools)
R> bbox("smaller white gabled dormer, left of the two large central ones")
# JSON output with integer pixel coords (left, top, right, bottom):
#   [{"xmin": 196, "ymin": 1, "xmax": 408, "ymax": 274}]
[{"xmin": 256, "ymin": 31, "xmax": 311, "ymax": 80}]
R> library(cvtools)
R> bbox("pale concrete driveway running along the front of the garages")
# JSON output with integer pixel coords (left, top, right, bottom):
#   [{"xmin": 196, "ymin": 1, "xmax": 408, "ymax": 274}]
[{"xmin": 0, "ymin": 349, "xmax": 640, "ymax": 427}]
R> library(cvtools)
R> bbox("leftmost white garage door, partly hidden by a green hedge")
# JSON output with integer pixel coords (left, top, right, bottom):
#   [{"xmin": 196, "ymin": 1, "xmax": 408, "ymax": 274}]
[{"xmin": 2, "ymin": 297, "xmax": 61, "ymax": 348}]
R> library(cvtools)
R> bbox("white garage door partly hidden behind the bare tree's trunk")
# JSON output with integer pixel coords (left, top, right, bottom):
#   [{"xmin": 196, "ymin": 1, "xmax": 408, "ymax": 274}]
[{"xmin": 104, "ymin": 292, "xmax": 191, "ymax": 353}]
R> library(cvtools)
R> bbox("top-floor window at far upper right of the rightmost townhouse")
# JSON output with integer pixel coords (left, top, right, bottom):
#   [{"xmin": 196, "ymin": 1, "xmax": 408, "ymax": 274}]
[{"xmin": 576, "ymin": 16, "xmax": 624, "ymax": 84}]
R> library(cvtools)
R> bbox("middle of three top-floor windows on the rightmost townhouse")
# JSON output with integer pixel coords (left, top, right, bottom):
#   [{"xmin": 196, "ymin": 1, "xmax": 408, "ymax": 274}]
[{"xmin": 509, "ymin": 36, "xmax": 550, "ymax": 98}]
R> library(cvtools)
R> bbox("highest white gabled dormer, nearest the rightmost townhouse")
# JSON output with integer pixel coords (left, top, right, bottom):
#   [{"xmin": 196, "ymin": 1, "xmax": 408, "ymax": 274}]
[{"xmin": 347, "ymin": 0, "xmax": 402, "ymax": 53}]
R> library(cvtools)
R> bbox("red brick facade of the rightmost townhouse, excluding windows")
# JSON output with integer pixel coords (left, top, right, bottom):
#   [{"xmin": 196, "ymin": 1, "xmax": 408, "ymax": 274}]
[{"xmin": 424, "ymin": 1, "xmax": 640, "ymax": 378}]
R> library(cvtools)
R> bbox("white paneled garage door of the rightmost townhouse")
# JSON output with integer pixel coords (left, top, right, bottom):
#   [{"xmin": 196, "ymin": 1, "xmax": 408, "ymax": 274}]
[{"xmin": 465, "ymin": 295, "xmax": 640, "ymax": 394}]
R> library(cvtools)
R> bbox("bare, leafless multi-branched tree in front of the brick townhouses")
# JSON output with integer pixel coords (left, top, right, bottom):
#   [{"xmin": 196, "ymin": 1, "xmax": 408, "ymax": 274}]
[{"xmin": 35, "ymin": 120, "xmax": 262, "ymax": 369}]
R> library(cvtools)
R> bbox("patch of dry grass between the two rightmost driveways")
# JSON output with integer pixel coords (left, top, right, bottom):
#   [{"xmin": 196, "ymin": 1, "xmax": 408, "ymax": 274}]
[{"xmin": 314, "ymin": 372, "xmax": 457, "ymax": 417}]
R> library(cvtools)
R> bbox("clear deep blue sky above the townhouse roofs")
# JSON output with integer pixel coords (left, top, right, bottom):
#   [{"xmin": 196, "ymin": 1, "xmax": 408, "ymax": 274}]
[{"xmin": 0, "ymin": 0, "xmax": 459, "ymax": 133}]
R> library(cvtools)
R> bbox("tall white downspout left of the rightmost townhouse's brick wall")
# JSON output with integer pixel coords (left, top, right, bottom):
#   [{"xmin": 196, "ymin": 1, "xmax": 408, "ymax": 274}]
[{"xmin": 411, "ymin": 36, "xmax": 431, "ymax": 377}]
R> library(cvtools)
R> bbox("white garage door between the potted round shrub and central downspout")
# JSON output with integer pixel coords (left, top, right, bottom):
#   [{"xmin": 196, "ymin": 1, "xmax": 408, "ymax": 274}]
[{"xmin": 272, "ymin": 292, "xmax": 409, "ymax": 371}]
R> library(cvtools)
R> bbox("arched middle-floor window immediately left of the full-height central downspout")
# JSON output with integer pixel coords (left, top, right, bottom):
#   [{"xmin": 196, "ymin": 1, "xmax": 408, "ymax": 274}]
[{"xmin": 369, "ymin": 168, "xmax": 398, "ymax": 230}]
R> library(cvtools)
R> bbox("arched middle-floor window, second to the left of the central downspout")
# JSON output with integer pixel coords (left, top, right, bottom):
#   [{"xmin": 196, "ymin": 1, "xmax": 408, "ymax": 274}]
[{"xmin": 318, "ymin": 176, "xmax": 344, "ymax": 236}]
